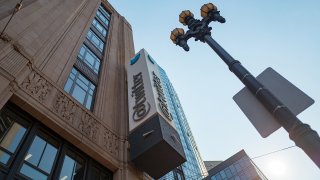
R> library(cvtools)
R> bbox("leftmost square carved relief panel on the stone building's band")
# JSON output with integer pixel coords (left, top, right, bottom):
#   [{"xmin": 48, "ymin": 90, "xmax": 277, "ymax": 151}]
[{"xmin": 21, "ymin": 71, "xmax": 52, "ymax": 103}]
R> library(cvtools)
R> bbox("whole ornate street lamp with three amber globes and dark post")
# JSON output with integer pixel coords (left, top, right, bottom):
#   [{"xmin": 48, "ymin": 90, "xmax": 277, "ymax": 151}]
[{"xmin": 170, "ymin": 3, "xmax": 320, "ymax": 168}]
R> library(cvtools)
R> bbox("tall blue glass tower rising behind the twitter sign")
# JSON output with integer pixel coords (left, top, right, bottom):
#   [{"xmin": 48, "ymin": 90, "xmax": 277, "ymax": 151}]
[{"xmin": 149, "ymin": 61, "xmax": 208, "ymax": 180}]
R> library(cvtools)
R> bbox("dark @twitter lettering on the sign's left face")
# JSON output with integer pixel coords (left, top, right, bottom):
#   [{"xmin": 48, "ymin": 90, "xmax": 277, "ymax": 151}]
[{"xmin": 131, "ymin": 72, "xmax": 150, "ymax": 121}]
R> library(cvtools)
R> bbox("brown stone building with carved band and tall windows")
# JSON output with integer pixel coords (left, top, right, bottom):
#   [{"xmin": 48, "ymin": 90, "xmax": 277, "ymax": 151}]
[{"xmin": 0, "ymin": 0, "xmax": 146, "ymax": 180}]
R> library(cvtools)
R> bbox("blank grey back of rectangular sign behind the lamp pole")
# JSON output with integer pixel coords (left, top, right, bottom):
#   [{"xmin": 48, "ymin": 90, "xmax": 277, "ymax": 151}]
[{"xmin": 233, "ymin": 67, "xmax": 314, "ymax": 138}]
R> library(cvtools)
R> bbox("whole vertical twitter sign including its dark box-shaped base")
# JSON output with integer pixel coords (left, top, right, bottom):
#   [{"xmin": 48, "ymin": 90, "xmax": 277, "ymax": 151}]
[{"xmin": 127, "ymin": 49, "xmax": 186, "ymax": 179}]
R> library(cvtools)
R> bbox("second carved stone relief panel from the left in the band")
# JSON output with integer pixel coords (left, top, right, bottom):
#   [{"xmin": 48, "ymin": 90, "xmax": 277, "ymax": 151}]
[{"xmin": 53, "ymin": 92, "xmax": 76, "ymax": 124}]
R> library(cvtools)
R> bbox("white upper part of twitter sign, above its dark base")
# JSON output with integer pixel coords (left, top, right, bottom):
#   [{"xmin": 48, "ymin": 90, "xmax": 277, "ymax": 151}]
[{"xmin": 127, "ymin": 49, "xmax": 174, "ymax": 131}]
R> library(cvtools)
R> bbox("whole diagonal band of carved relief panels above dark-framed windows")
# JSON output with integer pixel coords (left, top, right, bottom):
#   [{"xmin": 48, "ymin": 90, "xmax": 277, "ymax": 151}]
[{"xmin": 19, "ymin": 68, "xmax": 120, "ymax": 158}]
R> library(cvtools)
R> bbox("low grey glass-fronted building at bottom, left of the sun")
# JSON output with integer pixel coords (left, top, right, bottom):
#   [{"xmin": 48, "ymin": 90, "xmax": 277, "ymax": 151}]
[{"xmin": 204, "ymin": 150, "xmax": 267, "ymax": 180}]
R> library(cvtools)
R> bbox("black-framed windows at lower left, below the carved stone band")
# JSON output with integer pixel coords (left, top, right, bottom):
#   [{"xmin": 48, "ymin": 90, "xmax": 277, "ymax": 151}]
[{"xmin": 0, "ymin": 105, "xmax": 112, "ymax": 180}]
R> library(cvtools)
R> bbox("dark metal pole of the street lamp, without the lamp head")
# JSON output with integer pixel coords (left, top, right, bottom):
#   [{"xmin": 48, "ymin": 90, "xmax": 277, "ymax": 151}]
[{"xmin": 204, "ymin": 35, "xmax": 320, "ymax": 168}]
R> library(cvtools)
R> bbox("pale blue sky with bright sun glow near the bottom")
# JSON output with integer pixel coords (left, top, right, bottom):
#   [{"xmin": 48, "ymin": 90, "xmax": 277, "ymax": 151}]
[{"xmin": 109, "ymin": 0, "xmax": 320, "ymax": 180}]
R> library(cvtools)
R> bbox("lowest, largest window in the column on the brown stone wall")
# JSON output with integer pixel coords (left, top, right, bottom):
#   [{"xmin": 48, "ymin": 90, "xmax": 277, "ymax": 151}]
[{"xmin": 64, "ymin": 68, "xmax": 96, "ymax": 109}]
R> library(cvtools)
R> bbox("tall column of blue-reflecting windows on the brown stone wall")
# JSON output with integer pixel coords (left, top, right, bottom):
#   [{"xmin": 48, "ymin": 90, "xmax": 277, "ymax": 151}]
[{"xmin": 64, "ymin": 5, "xmax": 111, "ymax": 110}]
